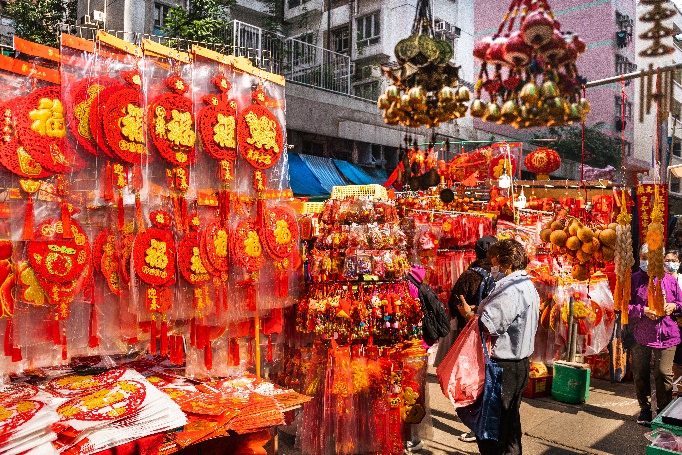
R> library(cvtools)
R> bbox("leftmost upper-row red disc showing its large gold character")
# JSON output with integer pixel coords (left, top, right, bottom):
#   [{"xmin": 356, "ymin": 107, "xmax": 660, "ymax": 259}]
[{"xmin": 14, "ymin": 86, "xmax": 85, "ymax": 173}]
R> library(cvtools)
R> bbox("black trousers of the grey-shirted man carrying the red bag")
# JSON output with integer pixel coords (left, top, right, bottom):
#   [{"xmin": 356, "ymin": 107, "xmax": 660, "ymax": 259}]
[{"xmin": 476, "ymin": 357, "xmax": 530, "ymax": 455}]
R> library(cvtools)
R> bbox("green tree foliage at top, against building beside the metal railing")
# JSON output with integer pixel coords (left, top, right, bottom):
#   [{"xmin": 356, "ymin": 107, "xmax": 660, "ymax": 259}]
[{"xmin": 164, "ymin": 0, "xmax": 237, "ymax": 43}]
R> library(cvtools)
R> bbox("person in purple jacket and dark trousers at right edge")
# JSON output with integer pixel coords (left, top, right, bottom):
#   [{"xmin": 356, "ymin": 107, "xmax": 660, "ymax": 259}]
[{"xmin": 628, "ymin": 244, "xmax": 682, "ymax": 426}]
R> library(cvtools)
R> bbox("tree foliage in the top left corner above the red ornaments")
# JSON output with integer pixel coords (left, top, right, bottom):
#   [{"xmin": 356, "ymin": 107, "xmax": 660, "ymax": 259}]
[{"xmin": 2, "ymin": 0, "xmax": 78, "ymax": 47}]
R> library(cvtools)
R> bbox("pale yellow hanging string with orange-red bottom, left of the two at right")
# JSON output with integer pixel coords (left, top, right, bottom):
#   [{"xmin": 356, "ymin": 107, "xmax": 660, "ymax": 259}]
[{"xmin": 613, "ymin": 191, "xmax": 635, "ymax": 324}]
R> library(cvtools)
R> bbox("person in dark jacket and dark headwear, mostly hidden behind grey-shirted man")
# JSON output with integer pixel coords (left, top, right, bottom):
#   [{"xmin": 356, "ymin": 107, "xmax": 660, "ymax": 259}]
[{"xmin": 448, "ymin": 236, "xmax": 499, "ymax": 442}]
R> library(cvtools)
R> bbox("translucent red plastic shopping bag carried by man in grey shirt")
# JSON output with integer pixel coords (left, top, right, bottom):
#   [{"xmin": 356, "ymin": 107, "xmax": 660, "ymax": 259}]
[{"xmin": 436, "ymin": 316, "xmax": 485, "ymax": 408}]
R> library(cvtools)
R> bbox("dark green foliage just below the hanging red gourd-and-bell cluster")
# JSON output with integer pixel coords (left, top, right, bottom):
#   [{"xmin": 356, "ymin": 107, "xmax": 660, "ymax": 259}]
[{"xmin": 535, "ymin": 122, "xmax": 622, "ymax": 169}]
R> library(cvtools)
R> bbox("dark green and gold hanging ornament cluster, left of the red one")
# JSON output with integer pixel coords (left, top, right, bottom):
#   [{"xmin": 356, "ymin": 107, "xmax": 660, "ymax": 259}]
[{"xmin": 377, "ymin": 0, "xmax": 471, "ymax": 128}]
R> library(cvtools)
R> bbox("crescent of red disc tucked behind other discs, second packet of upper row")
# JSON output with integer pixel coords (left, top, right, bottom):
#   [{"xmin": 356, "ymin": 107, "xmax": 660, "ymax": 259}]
[{"xmin": 64, "ymin": 76, "xmax": 118, "ymax": 155}]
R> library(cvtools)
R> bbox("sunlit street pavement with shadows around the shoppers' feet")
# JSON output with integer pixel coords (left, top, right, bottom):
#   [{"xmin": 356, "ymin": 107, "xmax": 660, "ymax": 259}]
[{"xmin": 279, "ymin": 368, "xmax": 649, "ymax": 455}]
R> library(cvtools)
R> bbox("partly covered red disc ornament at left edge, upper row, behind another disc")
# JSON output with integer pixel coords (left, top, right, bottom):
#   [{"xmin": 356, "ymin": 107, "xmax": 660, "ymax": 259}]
[{"xmin": 0, "ymin": 97, "xmax": 52, "ymax": 179}]
